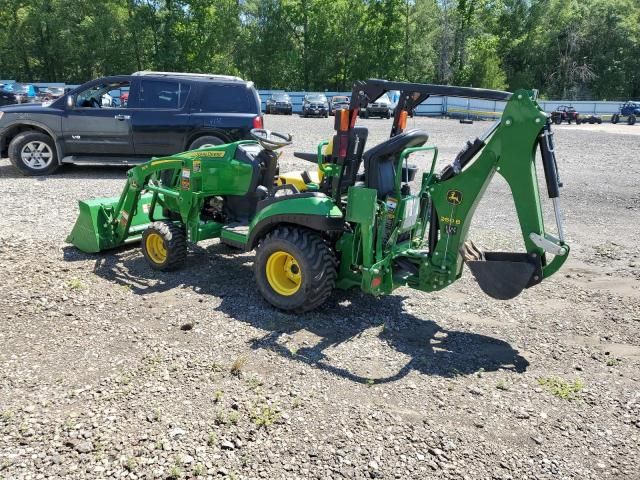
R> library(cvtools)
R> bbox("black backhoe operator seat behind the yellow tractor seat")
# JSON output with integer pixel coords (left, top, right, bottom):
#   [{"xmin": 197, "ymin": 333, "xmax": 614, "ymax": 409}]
[{"xmin": 362, "ymin": 129, "xmax": 429, "ymax": 199}]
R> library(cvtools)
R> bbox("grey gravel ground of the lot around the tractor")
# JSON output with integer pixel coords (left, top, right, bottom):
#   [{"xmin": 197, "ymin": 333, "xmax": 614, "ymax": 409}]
[{"xmin": 0, "ymin": 116, "xmax": 640, "ymax": 480}]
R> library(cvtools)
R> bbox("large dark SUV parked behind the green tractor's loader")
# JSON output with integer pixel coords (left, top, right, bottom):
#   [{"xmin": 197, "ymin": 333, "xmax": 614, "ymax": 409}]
[{"xmin": 0, "ymin": 72, "xmax": 263, "ymax": 175}]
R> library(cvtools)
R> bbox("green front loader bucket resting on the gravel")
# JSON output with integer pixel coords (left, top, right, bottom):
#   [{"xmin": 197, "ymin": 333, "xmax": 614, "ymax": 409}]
[{"xmin": 67, "ymin": 194, "xmax": 163, "ymax": 253}]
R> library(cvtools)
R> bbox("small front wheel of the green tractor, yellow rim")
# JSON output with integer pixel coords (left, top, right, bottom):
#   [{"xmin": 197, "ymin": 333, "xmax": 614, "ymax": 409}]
[{"xmin": 142, "ymin": 221, "xmax": 187, "ymax": 272}]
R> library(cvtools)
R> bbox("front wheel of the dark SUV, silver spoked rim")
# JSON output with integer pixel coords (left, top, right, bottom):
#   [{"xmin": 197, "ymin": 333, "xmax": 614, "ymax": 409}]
[{"xmin": 9, "ymin": 131, "xmax": 60, "ymax": 176}]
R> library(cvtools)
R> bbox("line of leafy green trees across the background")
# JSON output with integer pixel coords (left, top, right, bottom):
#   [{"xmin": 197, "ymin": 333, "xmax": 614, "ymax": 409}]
[{"xmin": 0, "ymin": 0, "xmax": 640, "ymax": 99}]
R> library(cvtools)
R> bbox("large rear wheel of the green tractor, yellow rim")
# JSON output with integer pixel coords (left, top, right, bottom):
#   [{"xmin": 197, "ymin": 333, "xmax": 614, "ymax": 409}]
[{"xmin": 254, "ymin": 227, "xmax": 337, "ymax": 313}]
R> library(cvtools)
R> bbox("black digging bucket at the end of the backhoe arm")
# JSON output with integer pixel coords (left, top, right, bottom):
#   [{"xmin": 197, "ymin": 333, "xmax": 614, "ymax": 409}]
[{"xmin": 466, "ymin": 252, "xmax": 542, "ymax": 300}]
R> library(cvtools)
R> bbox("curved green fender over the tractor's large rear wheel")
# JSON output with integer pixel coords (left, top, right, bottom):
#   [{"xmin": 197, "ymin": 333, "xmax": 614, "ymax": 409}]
[{"xmin": 246, "ymin": 192, "xmax": 344, "ymax": 250}]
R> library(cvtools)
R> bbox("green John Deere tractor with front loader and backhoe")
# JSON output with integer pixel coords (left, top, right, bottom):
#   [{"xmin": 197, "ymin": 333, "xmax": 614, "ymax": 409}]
[{"xmin": 67, "ymin": 80, "xmax": 569, "ymax": 313}]
